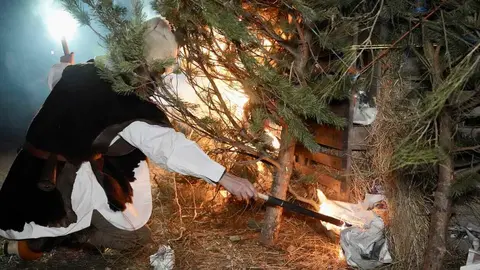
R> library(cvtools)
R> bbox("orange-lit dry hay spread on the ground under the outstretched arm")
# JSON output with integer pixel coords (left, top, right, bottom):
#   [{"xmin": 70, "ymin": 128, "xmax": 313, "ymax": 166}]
[{"xmin": 142, "ymin": 167, "xmax": 346, "ymax": 269}]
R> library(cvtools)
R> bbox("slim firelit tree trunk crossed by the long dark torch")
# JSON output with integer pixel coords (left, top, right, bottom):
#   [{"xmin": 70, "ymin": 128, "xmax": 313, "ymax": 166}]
[{"xmin": 260, "ymin": 127, "xmax": 295, "ymax": 245}]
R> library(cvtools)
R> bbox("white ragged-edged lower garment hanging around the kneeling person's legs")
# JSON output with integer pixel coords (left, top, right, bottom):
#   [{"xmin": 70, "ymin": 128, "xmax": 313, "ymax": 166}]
[{"xmin": 0, "ymin": 161, "xmax": 152, "ymax": 240}]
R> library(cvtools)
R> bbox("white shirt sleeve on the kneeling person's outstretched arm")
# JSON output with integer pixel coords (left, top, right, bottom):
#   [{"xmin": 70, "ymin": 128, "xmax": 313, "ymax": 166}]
[{"xmin": 118, "ymin": 121, "xmax": 225, "ymax": 184}]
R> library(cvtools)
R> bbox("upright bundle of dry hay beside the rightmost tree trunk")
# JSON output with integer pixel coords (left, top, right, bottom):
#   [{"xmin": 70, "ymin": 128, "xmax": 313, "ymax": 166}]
[{"xmin": 351, "ymin": 52, "xmax": 429, "ymax": 269}]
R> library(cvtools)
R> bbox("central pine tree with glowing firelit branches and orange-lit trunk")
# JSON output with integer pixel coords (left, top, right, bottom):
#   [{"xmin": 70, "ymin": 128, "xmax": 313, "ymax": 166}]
[{"xmin": 63, "ymin": 0, "xmax": 352, "ymax": 246}]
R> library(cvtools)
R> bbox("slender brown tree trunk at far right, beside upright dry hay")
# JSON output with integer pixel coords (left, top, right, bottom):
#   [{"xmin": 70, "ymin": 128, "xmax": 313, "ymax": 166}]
[{"xmin": 423, "ymin": 111, "xmax": 454, "ymax": 270}]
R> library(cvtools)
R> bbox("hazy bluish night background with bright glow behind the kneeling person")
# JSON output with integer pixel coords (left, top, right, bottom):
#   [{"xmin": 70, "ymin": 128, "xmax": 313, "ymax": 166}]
[{"xmin": 0, "ymin": 0, "xmax": 109, "ymax": 152}]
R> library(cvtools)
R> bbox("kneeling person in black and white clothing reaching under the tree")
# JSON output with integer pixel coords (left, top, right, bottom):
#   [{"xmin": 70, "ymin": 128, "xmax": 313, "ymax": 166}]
[{"xmin": 0, "ymin": 18, "xmax": 256, "ymax": 259}]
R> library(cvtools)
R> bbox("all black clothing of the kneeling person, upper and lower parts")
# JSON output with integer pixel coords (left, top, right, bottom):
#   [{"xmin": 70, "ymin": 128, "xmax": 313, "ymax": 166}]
[{"xmin": 0, "ymin": 63, "xmax": 171, "ymax": 231}]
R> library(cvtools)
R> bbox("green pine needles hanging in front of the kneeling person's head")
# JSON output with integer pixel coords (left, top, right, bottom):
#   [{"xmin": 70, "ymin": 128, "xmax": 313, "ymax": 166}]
[{"xmin": 60, "ymin": 0, "xmax": 175, "ymax": 98}]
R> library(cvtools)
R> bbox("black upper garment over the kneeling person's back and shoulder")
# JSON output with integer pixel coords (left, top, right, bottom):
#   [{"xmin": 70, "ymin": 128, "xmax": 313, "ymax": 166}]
[{"xmin": 26, "ymin": 63, "xmax": 171, "ymax": 164}]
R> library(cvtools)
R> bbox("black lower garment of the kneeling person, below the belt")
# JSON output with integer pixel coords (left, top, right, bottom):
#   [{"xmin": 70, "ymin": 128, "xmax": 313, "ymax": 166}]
[{"xmin": 0, "ymin": 149, "xmax": 146, "ymax": 231}]
